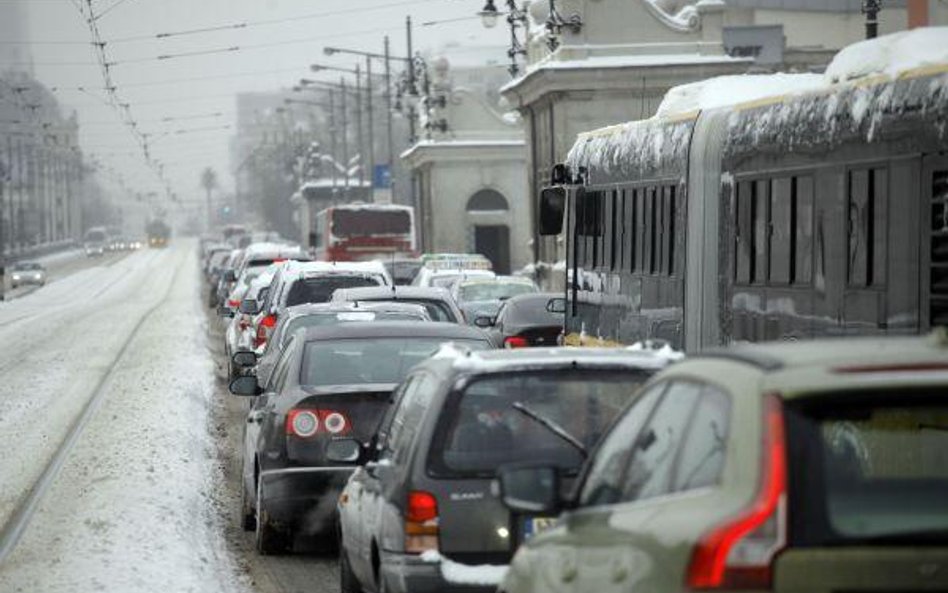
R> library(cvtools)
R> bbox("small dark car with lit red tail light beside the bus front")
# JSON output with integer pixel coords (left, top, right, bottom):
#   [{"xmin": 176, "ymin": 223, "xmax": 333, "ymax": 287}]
[{"xmin": 474, "ymin": 292, "xmax": 565, "ymax": 348}]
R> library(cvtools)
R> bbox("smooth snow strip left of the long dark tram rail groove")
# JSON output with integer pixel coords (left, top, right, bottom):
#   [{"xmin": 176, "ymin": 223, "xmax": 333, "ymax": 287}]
[{"xmin": 0, "ymin": 247, "xmax": 168, "ymax": 524}]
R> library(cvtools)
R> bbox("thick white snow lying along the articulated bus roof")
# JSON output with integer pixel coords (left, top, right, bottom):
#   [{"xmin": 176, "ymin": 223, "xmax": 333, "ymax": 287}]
[{"xmin": 570, "ymin": 27, "xmax": 948, "ymax": 147}]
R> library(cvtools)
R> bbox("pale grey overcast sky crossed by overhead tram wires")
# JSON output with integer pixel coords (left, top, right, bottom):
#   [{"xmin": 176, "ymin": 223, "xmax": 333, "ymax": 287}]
[{"xmin": 24, "ymin": 0, "xmax": 508, "ymax": 201}]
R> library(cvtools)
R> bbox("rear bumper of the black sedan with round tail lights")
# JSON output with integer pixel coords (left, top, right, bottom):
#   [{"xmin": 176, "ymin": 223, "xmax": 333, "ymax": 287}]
[{"xmin": 260, "ymin": 467, "xmax": 355, "ymax": 533}]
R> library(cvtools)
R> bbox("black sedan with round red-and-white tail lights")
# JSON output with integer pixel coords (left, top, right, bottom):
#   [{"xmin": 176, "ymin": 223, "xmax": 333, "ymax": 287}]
[{"xmin": 230, "ymin": 321, "xmax": 491, "ymax": 553}]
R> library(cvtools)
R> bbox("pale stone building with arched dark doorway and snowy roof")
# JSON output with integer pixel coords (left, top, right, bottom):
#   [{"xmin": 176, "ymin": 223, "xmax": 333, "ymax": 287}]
[{"xmin": 401, "ymin": 59, "xmax": 532, "ymax": 274}]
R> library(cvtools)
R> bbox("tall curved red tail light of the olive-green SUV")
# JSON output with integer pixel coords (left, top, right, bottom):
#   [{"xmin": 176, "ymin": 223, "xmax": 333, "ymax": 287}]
[{"xmin": 687, "ymin": 395, "xmax": 787, "ymax": 590}]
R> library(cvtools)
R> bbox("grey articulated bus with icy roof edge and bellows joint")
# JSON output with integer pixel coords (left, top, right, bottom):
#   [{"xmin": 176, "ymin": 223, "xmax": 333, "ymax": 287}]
[{"xmin": 538, "ymin": 29, "xmax": 948, "ymax": 351}]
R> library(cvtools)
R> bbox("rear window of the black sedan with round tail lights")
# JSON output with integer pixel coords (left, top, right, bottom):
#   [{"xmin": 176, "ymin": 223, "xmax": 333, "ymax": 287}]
[{"xmin": 300, "ymin": 337, "xmax": 489, "ymax": 387}]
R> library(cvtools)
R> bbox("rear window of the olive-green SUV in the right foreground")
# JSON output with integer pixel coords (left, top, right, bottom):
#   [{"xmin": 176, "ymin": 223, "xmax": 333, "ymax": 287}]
[{"xmin": 788, "ymin": 392, "xmax": 948, "ymax": 545}]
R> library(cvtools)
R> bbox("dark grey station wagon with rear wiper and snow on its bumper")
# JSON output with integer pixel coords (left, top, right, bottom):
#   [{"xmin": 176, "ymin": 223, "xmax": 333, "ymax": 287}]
[{"xmin": 329, "ymin": 348, "xmax": 672, "ymax": 593}]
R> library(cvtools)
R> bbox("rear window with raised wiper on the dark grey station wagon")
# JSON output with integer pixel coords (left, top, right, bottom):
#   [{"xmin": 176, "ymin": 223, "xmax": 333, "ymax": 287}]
[{"xmin": 429, "ymin": 370, "xmax": 650, "ymax": 477}]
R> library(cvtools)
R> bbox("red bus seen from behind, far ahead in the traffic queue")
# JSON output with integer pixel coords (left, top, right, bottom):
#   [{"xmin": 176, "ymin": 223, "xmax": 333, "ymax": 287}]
[{"xmin": 313, "ymin": 204, "xmax": 417, "ymax": 261}]
